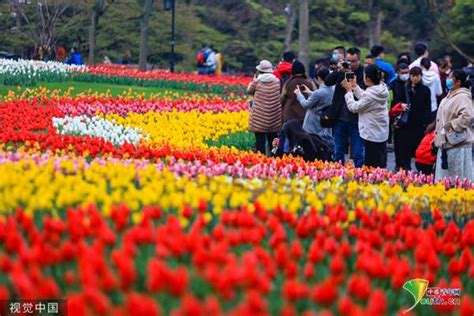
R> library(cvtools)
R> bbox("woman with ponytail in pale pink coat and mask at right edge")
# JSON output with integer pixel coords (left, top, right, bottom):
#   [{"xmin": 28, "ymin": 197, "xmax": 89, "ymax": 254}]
[{"xmin": 435, "ymin": 69, "xmax": 474, "ymax": 181}]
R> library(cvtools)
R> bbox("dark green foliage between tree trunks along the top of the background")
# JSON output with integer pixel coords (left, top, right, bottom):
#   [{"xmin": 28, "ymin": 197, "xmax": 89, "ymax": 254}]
[{"xmin": 0, "ymin": 0, "xmax": 474, "ymax": 71}]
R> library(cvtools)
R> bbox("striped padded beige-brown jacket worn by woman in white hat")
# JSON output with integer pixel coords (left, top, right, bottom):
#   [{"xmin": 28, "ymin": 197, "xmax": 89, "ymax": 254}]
[{"xmin": 247, "ymin": 74, "xmax": 282, "ymax": 133}]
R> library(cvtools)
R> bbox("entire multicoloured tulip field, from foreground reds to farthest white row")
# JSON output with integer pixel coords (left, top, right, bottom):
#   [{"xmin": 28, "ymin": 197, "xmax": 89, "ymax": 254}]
[{"xmin": 0, "ymin": 59, "xmax": 474, "ymax": 316}]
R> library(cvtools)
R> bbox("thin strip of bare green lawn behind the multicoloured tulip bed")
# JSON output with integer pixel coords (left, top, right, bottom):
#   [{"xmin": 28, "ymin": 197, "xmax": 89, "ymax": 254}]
[{"xmin": 0, "ymin": 81, "xmax": 190, "ymax": 98}]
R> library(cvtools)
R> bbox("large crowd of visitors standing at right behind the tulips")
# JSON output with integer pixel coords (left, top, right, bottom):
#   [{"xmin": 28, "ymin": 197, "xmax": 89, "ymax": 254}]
[{"xmin": 248, "ymin": 43, "xmax": 474, "ymax": 181}]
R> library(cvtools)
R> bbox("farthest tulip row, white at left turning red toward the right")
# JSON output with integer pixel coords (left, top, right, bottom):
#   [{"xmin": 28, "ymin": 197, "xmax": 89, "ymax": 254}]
[{"xmin": 0, "ymin": 59, "xmax": 250, "ymax": 95}]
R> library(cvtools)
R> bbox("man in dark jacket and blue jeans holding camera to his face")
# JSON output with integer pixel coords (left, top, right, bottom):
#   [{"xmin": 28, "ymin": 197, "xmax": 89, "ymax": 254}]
[{"xmin": 324, "ymin": 47, "xmax": 366, "ymax": 167}]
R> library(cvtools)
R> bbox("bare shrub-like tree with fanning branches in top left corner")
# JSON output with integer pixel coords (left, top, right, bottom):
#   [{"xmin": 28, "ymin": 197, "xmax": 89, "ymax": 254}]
[{"xmin": 9, "ymin": 0, "xmax": 73, "ymax": 53}]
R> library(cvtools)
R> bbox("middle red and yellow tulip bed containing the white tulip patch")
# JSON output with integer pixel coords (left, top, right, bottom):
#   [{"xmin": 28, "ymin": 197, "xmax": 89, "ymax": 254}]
[{"xmin": 0, "ymin": 90, "xmax": 472, "ymax": 188}]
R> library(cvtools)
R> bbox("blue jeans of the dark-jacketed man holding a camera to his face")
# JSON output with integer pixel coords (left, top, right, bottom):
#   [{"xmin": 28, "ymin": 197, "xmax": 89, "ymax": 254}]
[{"xmin": 333, "ymin": 120, "xmax": 364, "ymax": 168}]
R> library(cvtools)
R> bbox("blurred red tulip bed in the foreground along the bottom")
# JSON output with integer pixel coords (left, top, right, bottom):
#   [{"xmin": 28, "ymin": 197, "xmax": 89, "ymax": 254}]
[{"xmin": 0, "ymin": 195, "xmax": 474, "ymax": 316}]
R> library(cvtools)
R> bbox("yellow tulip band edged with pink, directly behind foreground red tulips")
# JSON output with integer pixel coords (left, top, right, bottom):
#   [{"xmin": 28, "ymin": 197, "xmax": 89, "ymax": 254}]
[{"xmin": 0, "ymin": 153, "xmax": 474, "ymax": 216}]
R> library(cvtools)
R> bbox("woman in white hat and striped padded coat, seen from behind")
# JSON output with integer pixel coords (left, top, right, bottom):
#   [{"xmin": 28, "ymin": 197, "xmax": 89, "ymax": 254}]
[{"xmin": 247, "ymin": 60, "xmax": 282, "ymax": 154}]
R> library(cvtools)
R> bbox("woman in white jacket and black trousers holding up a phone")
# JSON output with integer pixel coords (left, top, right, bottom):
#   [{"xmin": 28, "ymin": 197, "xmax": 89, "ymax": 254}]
[{"xmin": 342, "ymin": 65, "xmax": 389, "ymax": 168}]
